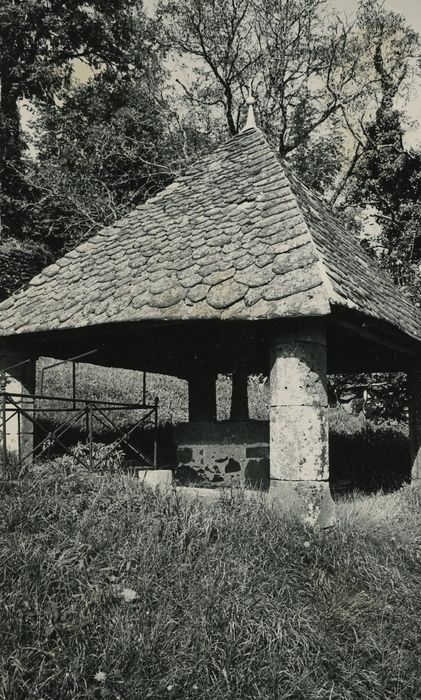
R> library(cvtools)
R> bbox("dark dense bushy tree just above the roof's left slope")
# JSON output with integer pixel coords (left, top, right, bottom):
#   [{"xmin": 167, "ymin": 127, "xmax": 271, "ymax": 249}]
[{"xmin": 31, "ymin": 67, "xmax": 220, "ymax": 254}]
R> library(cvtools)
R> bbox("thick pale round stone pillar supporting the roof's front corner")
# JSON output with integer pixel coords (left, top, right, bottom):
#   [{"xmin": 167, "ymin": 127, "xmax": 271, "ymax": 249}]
[{"xmin": 270, "ymin": 319, "xmax": 335, "ymax": 527}]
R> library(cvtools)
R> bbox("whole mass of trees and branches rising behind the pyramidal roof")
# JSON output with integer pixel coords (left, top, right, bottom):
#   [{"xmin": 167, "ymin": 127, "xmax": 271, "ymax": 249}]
[{"xmin": 0, "ymin": 0, "xmax": 421, "ymax": 314}]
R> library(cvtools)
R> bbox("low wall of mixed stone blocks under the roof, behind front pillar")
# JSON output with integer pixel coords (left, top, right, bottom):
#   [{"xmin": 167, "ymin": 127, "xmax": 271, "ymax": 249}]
[{"xmin": 174, "ymin": 420, "xmax": 269, "ymax": 488}]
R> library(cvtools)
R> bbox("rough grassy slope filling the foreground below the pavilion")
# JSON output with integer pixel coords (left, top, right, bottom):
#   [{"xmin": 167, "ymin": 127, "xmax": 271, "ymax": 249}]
[{"xmin": 0, "ymin": 461, "xmax": 421, "ymax": 700}]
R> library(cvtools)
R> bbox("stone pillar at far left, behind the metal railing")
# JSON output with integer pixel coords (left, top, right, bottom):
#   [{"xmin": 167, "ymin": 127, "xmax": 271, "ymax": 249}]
[{"xmin": 0, "ymin": 348, "xmax": 35, "ymax": 473}]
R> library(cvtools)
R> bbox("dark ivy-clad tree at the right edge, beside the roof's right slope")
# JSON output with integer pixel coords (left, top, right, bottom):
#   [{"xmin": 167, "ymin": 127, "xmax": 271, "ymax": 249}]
[{"xmin": 345, "ymin": 0, "xmax": 421, "ymax": 300}]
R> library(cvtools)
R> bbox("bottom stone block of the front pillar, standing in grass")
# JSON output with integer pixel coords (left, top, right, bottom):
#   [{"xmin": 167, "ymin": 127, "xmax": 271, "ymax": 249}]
[{"xmin": 268, "ymin": 479, "xmax": 336, "ymax": 528}]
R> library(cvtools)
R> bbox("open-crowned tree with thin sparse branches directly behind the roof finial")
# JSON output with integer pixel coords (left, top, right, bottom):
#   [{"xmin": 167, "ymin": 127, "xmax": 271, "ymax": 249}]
[{"xmin": 158, "ymin": 0, "xmax": 364, "ymax": 154}]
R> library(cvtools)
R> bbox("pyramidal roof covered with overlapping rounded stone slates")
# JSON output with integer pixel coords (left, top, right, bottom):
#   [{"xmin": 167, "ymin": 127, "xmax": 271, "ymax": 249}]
[{"xmin": 0, "ymin": 129, "xmax": 421, "ymax": 339}]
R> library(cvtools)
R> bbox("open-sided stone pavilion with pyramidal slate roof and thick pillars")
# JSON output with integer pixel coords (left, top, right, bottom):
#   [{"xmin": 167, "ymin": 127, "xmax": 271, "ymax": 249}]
[{"xmin": 0, "ymin": 121, "xmax": 421, "ymax": 523}]
